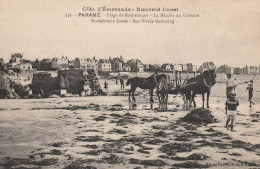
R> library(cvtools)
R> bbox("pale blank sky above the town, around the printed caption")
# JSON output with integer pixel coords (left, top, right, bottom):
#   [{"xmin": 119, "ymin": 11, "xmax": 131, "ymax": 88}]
[{"xmin": 0, "ymin": 0, "xmax": 260, "ymax": 67}]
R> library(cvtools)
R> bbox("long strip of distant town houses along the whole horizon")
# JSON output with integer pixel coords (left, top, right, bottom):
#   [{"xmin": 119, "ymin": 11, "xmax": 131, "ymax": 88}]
[{"xmin": 0, "ymin": 53, "xmax": 260, "ymax": 75}]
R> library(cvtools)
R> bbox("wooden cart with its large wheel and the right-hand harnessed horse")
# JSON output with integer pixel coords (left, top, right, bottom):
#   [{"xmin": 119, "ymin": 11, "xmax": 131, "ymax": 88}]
[{"xmin": 156, "ymin": 70, "xmax": 216, "ymax": 110}]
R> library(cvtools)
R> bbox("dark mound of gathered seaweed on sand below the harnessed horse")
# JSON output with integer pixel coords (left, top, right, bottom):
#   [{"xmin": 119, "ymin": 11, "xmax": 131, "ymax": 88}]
[{"xmin": 182, "ymin": 108, "xmax": 217, "ymax": 124}]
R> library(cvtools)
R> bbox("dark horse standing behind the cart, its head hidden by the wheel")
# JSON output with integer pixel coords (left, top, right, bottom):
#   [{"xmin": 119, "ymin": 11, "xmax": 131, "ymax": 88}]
[{"xmin": 126, "ymin": 73, "xmax": 167, "ymax": 102}]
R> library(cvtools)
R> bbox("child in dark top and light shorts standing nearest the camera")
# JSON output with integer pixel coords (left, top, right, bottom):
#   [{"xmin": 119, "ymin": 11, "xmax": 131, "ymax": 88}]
[{"xmin": 226, "ymin": 90, "xmax": 239, "ymax": 131}]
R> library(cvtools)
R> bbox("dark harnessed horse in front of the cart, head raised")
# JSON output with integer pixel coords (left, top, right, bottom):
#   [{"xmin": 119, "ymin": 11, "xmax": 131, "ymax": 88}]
[{"xmin": 184, "ymin": 70, "xmax": 216, "ymax": 108}]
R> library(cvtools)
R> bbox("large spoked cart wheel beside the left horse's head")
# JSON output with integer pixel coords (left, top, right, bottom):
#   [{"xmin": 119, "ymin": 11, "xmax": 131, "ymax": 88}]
[{"xmin": 156, "ymin": 78, "xmax": 168, "ymax": 110}]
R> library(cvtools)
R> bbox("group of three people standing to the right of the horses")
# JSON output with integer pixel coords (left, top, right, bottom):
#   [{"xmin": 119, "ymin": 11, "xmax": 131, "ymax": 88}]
[{"xmin": 225, "ymin": 74, "xmax": 254, "ymax": 131}]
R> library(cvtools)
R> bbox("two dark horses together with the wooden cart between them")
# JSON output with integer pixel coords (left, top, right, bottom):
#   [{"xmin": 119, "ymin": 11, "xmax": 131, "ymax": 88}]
[{"xmin": 126, "ymin": 70, "xmax": 216, "ymax": 109}]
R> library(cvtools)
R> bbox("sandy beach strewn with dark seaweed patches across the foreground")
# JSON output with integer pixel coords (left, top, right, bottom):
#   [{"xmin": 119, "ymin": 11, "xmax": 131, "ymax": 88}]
[{"xmin": 0, "ymin": 78, "xmax": 260, "ymax": 169}]
